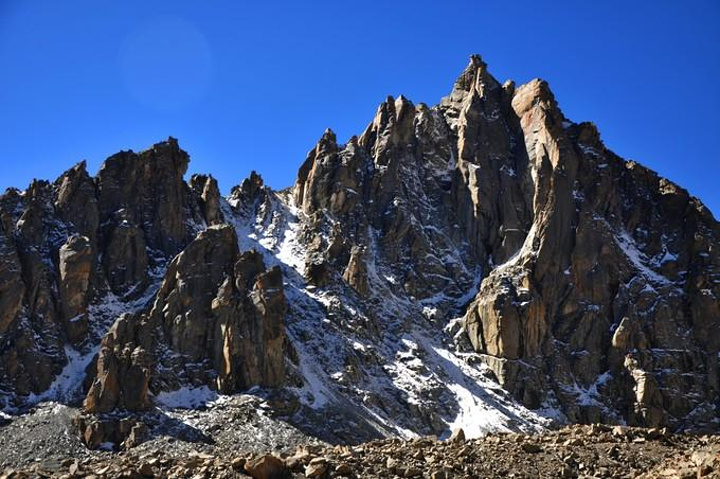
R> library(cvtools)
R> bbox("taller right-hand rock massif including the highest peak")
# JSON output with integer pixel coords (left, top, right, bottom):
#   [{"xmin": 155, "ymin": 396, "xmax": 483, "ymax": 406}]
[{"xmin": 293, "ymin": 56, "xmax": 720, "ymax": 428}]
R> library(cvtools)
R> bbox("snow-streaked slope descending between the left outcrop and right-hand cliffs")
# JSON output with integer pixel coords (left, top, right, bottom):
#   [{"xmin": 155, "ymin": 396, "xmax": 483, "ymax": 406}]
[{"xmin": 218, "ymin": 189, "xmax": 561, "ymax": 437}]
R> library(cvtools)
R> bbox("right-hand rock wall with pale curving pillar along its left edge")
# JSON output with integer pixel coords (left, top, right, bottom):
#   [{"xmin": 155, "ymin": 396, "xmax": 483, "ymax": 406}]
[{"xmin": 459, "ymin": 65, "xmax": 720, "ymax": 427}]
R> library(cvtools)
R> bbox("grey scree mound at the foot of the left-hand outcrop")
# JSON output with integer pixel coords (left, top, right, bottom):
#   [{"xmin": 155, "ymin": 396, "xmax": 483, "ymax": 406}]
[{"xmin": 0, "ymin": 395, "xmax": 320, "ymax": 473}]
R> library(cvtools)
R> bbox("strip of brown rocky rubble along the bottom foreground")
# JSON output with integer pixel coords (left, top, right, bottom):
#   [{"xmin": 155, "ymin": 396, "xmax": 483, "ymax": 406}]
[{"xmin": 3, "ymin": 425, "xmax": 720, "ymax": 479}]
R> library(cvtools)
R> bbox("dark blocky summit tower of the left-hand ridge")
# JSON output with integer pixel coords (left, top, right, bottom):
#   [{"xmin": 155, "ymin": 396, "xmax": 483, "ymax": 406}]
[{"xmin": 97, "ymin": 138, "xmax": 207, "ymax": 293}]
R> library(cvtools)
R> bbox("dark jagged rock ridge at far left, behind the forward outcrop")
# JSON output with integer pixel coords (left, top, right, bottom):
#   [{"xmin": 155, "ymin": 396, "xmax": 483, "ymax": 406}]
[{"xmin": 0, "ymin": 138, "xmax": 231, "ymax": 410}]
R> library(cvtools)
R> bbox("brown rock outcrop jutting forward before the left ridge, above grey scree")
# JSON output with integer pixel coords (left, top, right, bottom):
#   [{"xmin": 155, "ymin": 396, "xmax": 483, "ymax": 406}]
[{"xmin": 85, "ymin": 225, "xmax": 287, "ymax": 413}]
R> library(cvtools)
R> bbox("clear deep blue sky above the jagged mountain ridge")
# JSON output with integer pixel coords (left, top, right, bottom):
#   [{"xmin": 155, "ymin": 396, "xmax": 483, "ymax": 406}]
[{"xmin": 0, "ymin": 0, "xmax": 720, "ymax": 216}]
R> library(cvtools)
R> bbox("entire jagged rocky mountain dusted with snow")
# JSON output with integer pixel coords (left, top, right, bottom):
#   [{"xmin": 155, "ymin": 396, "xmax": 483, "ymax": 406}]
[{"xmin": 0, "ymin": 55, "xmax": 720, "ymax": 454}]
